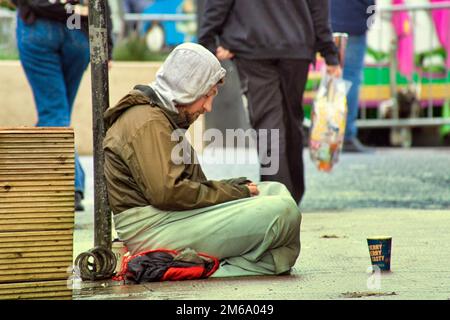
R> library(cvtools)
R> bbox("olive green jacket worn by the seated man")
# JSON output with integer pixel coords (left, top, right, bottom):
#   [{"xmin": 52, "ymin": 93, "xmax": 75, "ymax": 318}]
[{"xmin": 103, "ymin": 86, "xmax": 250, "ymax": 214}]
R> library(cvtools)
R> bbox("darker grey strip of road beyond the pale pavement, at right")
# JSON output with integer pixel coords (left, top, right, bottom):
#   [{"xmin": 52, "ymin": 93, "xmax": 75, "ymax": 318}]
[{"xmin": 301, "ymin": 148, "xmax": 450, "ymax": 212}]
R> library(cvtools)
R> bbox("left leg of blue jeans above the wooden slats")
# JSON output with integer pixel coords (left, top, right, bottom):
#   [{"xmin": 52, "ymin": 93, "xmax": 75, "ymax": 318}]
[{"xmin": 17, "ymin": 17, "xmax": 70, "ymax": 127}]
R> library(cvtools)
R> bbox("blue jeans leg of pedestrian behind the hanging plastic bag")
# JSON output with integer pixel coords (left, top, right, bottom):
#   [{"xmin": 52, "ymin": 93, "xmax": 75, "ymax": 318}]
[{"xmin": 344, "ymin": 34, "xmax": 367, "ymax": 140}]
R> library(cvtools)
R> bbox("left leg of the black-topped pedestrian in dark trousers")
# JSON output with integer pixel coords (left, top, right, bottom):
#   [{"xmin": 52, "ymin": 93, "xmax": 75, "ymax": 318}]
[{"xmin": 235, "ymin": 58, "xmax": 294, "ymax": 196}]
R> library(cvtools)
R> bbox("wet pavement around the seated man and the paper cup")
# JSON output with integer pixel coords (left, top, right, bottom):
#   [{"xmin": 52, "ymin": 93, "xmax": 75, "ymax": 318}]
[{"xmin": 74, "ymin": 149, "xmax": 450, "ymax": 300}]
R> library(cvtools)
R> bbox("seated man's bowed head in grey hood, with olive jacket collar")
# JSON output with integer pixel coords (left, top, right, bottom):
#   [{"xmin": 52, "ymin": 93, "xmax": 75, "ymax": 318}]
[{"xmin": 104, "ymin": 43, "xmax": 226, "ymax": 128}]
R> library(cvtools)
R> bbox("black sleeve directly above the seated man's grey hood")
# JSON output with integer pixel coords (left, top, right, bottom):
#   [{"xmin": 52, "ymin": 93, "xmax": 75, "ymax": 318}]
[{"xmin": 198, "ymin": 0, "xmax": 234, "ymax": 54}]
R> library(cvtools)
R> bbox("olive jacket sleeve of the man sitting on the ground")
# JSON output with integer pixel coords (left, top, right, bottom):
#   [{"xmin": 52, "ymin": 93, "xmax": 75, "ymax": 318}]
[{"xmin": 127, "ymin": 120, "xmax": 250, "ymax": 210}]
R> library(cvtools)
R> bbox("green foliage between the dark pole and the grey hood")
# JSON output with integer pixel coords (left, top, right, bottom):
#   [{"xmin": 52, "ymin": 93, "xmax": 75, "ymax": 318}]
[{"xmin": 113, "ymin": 34, "xmax": 168, "ymax": 61}]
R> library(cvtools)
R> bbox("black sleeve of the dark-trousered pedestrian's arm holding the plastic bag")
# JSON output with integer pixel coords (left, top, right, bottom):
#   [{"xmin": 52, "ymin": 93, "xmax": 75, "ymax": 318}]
[{"xmin": 307, "ymin": 0, "xmax": 339, "ymax": 65}]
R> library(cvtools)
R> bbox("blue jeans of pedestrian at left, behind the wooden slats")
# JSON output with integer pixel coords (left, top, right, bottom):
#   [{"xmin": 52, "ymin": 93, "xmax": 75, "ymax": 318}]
[{"xmin": 17, "ymin": 16, "xmax": 90, "ymax": 193}]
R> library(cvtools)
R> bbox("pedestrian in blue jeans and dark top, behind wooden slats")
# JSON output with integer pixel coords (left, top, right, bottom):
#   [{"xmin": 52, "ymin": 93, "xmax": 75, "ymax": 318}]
[{"xmin": 13, "ymin": 0, "xmax": 112, "ymax": 211}]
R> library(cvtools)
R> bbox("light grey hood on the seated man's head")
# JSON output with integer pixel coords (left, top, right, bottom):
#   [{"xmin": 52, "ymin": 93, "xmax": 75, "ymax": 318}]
[{"xmin": 150, "ymin": 43, "xmax": 226, "ymax": 112}]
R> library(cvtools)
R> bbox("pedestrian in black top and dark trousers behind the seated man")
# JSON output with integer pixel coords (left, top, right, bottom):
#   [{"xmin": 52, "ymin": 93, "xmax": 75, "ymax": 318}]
[{"xmin": 199, "ymin": 0, "xmax": 340, "ymax": 203}]
